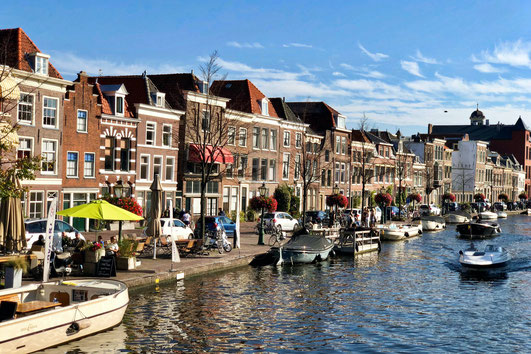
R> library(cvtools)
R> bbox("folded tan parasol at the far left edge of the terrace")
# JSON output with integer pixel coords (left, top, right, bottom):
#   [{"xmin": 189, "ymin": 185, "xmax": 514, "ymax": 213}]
[{"xmin": 0, "ymin": 175, "xmax": 26, "ymax": 252}]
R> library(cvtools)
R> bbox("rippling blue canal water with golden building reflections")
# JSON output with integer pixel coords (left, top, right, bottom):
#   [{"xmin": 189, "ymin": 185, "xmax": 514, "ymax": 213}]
[{"xmin": 47, "ymin": 215, "xmax": 531, "ymax": 353}]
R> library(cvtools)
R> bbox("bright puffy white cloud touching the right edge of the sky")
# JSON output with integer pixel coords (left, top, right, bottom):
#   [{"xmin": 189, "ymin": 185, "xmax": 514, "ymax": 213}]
[{"xmin": 480, "ymin": 39, "xmax": 531, "ymax": 68}]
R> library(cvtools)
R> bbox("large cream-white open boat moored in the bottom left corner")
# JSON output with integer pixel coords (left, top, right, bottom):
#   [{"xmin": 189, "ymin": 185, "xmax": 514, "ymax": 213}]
[{"xmin": 0, "ymin": 279, "xmax": 129, "ymax": 353}]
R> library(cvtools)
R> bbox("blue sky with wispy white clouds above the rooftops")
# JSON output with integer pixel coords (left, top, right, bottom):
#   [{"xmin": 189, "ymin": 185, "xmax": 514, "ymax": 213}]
[{"xmin": 0, "ymin": 0, "xmax": 531, "ymax": 134}]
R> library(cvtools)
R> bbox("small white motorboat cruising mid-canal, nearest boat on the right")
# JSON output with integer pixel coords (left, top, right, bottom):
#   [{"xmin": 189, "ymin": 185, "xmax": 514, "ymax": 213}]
[{"xmin": 459, "ymin": 243, "xmax": 511, "ymax": 268}]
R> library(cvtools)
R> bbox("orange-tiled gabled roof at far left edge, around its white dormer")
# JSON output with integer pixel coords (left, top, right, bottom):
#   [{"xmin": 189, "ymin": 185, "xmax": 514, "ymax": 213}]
[{"xmin": 0, "ymin": 28, "xmax": 63, "ymax": 79}]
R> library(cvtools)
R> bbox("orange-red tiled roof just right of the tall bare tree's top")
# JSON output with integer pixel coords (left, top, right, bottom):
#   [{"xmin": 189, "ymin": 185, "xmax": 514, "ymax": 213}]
[{"xmin": 210, "ymin": 80, "xmax": 279, "ymax": 117}]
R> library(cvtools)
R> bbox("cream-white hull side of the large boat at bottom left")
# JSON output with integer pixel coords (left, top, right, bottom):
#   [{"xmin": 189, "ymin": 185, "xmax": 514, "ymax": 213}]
[{"xmin": 0, "ymin": 280, "xmax": 129, "ymax": 353}]
